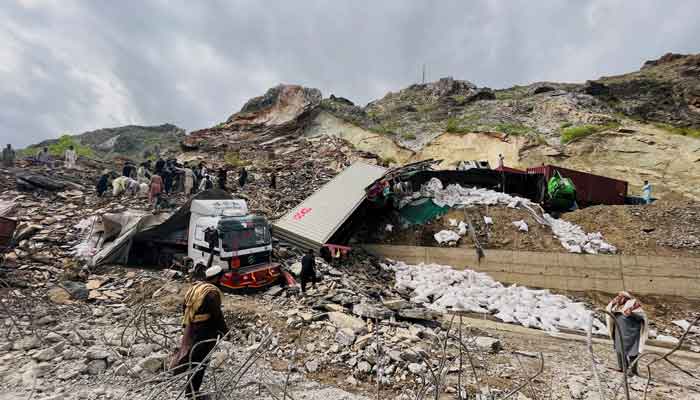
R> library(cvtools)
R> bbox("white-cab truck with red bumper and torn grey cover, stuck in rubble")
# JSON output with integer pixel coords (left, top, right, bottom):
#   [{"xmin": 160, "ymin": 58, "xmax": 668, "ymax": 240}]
[{"xmin": 87, "ymin": 190, "xmax": 281, "ymax": 289}]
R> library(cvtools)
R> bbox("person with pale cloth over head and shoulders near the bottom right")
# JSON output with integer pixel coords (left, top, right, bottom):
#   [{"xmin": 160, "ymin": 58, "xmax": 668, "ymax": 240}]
[{"xmin": 605, "ymin": 292, "xmax": 649, "ymax": 375}]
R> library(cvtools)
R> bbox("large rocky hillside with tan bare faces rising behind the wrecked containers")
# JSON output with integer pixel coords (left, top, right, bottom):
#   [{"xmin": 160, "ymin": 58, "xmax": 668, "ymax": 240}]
[{"xmin": 183, "ymin": 54, "xmax": 700, "ymax": 200}]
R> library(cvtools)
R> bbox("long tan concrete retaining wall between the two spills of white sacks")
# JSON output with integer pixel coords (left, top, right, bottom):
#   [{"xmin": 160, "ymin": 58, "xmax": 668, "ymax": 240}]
[{"xmin": 363, "ymin": 245, "xmax": 700, "ymax": 298}]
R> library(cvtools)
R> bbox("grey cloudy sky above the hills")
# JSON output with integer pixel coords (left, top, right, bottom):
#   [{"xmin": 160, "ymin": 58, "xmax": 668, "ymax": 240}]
[{"xmin": 0, "ymin": 0, "xmax": 700, "ymax": 146}]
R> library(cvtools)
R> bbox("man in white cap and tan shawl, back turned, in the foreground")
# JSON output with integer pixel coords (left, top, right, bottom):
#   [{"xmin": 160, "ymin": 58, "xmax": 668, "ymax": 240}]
[{"xmin": 171, "ymin": 265, "xmax": 228, "ymax": 399}]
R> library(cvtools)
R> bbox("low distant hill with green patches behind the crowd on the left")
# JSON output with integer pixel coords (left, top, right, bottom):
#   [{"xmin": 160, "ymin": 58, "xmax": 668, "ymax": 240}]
[{"xmin": 24, "ymin": 124, "xmax": 186, "ymax": 160}]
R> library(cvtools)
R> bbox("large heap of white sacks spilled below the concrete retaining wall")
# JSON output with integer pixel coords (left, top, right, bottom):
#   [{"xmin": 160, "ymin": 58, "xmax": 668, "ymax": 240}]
[{"xmin": 388, "ymin": 262, "xmax": 607, "ymax": 335}]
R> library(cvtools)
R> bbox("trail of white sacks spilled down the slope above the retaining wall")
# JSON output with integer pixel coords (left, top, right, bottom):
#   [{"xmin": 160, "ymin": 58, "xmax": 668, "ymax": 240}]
[{"xmin": 420, "ymin": 178, "xmax": 617, "ymax": 254}]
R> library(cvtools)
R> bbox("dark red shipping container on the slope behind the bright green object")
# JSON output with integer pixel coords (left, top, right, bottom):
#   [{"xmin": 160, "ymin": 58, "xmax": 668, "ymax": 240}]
[{"xmin": 527, "ymin": 165, "xmax": 628, "ymax": 207}]
